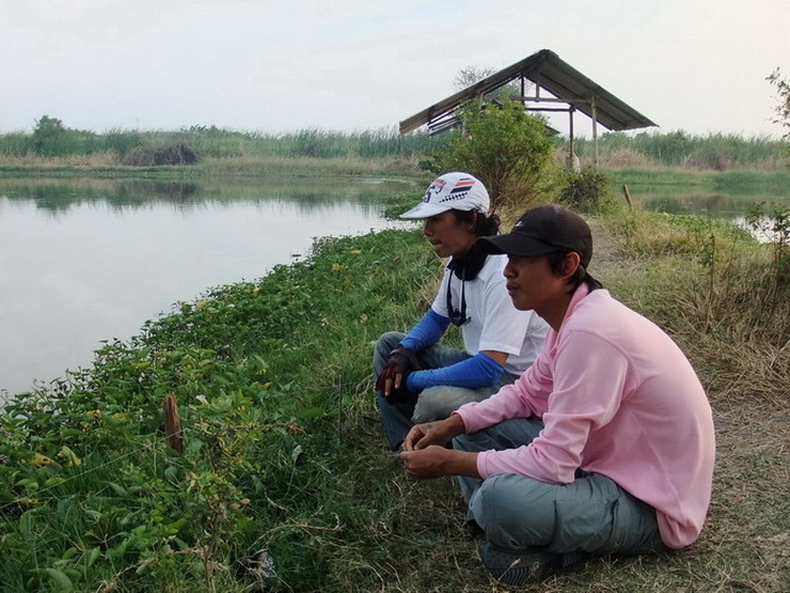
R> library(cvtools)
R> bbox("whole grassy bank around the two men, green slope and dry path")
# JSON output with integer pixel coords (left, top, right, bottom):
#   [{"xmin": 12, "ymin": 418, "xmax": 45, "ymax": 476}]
[{"xmin": 0, "ymin": 201, "xmax": 790, "ymax": 593}]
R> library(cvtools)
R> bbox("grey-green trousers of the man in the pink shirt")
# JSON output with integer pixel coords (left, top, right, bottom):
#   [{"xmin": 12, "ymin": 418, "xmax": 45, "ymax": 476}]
[{"xmin": 453, "ymin": 419, "xmax": 667, "ymax": 554}]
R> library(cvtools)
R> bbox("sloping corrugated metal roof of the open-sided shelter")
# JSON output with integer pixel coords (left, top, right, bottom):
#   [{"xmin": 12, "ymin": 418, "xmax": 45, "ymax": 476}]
[{"xmin": 400, "ymin": 49, "xmax": 656, "ymax": 134}]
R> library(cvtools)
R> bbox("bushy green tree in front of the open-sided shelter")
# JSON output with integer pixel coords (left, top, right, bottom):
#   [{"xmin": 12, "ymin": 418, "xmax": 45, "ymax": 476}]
[{"xmin": 427, "ymin": 99, "xmax": 554, "ymax": 208}]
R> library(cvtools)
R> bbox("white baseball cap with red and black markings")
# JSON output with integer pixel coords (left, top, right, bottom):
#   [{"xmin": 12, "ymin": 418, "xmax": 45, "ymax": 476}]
[{"xmin": 400, "ymin": 171, "xmax": 491, "ymax": 218}]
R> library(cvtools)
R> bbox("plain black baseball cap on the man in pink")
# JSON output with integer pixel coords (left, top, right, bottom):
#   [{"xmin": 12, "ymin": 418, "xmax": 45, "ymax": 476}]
[{"xmin": 478, "ymin": 204, "xmax": 592, "ymax": 268}]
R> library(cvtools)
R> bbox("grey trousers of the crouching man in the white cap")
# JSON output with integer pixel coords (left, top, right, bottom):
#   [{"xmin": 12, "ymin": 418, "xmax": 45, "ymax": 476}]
[{"xmin": 373, "ymin": 332, "xmax": 517, "ymax": 451}]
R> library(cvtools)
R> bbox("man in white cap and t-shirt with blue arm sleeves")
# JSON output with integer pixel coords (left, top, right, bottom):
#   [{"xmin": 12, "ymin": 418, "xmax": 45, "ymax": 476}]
[{"xmin": 373, "ymin": 172, "xmax": 548, "ymax": 450}]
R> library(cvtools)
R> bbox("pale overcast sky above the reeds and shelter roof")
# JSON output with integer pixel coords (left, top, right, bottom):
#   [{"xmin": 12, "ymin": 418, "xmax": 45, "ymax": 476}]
[{"xmin": 0, "ymin": 0, "xmax": 790, "ymax": 138}]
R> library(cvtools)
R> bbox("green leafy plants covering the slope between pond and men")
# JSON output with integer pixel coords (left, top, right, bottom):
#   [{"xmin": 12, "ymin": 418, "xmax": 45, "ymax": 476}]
[{"xmin": 0, "ymin": 227, "xmax": 440, "ymax": 591}]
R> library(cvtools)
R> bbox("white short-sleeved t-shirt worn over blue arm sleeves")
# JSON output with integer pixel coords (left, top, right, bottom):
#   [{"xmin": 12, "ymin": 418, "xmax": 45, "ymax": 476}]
[{"xmin": 431, "ymin": 255, "xmax": 548, "ymax": 375}]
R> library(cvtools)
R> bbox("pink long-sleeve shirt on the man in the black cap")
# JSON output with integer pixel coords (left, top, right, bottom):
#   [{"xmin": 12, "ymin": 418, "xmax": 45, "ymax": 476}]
[{"xmin": 456, "ymin": 285, "xmax": 715, "ymax": 548}]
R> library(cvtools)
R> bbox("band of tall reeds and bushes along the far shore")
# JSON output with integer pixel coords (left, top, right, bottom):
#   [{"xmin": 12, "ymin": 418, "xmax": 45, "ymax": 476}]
[{"xmin": 0, "ymin": 115, "xmax": 787, "ymax": 171}]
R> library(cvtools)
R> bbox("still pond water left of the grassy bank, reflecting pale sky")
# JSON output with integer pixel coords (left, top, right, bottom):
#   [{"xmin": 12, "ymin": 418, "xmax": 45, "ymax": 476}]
[{"xmin": 0, "ymin": 179, "xmax": 413, "ymax": 396}]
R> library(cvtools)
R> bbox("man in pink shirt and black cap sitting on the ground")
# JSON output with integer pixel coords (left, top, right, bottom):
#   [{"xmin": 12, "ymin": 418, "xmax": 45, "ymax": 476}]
[{"xmin": 399, "ymin": 205, "xmax": 715, "ymax": 585}]
